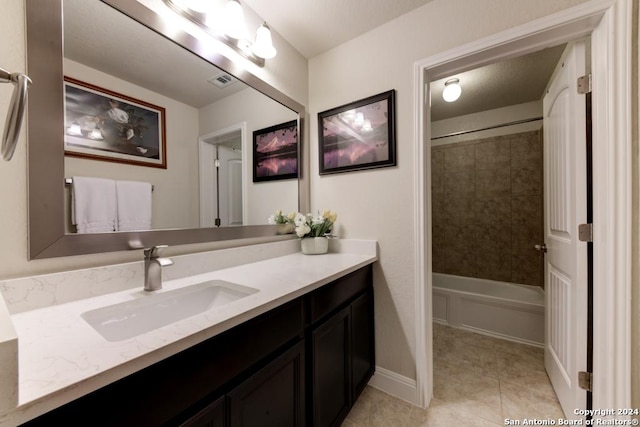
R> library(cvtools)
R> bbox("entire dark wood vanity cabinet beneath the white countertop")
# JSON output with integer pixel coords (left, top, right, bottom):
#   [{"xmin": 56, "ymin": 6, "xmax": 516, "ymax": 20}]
[{"xmin": 24, "ymin": 265, "xmax": 375, "ymax": 427}]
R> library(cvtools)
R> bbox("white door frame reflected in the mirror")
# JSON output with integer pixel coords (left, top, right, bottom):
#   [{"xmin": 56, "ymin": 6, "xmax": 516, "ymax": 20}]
[{"xmin": 198, "ymin": 122, "xmax": 249, "ymax": 227}]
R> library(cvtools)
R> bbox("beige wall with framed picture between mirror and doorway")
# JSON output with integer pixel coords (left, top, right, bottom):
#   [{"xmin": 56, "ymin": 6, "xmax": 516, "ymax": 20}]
[{"xmin": 309, "ymin": 0, "xmax": 582, "ymax": 378}]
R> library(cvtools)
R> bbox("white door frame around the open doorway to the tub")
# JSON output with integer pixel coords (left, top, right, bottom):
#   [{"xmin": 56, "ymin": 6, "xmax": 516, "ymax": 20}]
[{"xmin": 413, "ymin": 0, "xmax": 632, "ymax": 408}]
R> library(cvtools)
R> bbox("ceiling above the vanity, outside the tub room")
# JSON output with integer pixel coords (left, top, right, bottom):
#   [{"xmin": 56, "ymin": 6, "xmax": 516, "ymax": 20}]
[{"xmin": 242, "ymin": 0, "xmax": 438, "ymax": 59}]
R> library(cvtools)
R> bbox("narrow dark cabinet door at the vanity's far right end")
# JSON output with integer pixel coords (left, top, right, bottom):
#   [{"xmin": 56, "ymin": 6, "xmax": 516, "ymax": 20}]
[{"xmin": 351, "ymin": 289, "xmax": 375, "ymax": 402}]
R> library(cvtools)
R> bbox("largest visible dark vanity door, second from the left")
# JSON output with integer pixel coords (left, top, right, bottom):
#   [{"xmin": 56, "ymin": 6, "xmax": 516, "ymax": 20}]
[{"xmin": 227, "ymin": 341, "xmax": 305, "ymax": 427}]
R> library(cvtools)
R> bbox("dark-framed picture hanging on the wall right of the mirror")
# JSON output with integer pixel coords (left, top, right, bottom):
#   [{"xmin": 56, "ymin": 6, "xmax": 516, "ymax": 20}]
[{"xmin": 318, "ymin": 89, "xmax": 396, "ymax": 175}]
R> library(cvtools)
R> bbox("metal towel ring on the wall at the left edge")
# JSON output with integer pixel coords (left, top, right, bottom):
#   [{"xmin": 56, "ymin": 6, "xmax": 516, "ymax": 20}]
[{"xmin": 0, "ymin": 68, "xmax": 31, "ymax": 161}]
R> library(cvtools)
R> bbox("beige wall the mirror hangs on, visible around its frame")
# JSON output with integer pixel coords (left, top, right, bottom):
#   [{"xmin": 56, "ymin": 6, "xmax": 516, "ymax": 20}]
[{"xmin": 0, "ymin": 0, "xmax": 308, "ymax": 279}]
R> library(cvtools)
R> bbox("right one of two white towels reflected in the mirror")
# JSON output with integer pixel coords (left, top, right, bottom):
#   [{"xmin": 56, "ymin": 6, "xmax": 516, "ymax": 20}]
[{"xmin": 116, "ymin": 181, "xmax": 151, "ymax": 231}]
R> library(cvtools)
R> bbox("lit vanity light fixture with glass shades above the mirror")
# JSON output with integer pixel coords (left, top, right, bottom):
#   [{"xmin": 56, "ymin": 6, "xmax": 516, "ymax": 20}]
[{"xmin": 163, "ymin": 0, "xmax": 277, "ymax": 67}]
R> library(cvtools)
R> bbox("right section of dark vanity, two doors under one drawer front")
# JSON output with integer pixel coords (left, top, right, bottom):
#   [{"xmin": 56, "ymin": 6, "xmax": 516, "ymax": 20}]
[{"xmin": 308, "ymin": 269, "xmax": 375, "ymax": 427}]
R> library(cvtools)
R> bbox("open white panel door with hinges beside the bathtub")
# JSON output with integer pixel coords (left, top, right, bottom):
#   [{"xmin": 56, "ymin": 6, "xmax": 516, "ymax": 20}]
[{"xmin": 543, "ymin": 42, "xmax": 587, "ymax": 418}]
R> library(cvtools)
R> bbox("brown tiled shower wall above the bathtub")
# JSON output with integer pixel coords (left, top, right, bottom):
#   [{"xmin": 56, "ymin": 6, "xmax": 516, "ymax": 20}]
[{"xmin": 431, "ymin": 130, "xmax": 544, "ymax": 286}]
